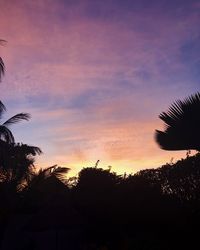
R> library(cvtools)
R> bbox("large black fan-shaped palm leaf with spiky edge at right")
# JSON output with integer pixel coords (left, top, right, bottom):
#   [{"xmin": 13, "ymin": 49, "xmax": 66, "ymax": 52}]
[{"xmin": 155, "ymin": 93, "xmax": 200, "ymax": 151}]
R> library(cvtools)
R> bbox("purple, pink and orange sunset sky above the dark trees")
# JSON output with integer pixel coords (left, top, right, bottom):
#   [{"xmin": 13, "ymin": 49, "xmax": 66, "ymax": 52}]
[{"xmin": 0, "ymin": 0, "xmax": 200, "ymax": 174}]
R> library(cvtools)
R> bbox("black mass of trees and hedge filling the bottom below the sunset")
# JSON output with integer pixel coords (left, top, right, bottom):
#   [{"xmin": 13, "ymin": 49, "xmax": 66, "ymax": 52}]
[{"xmin": 0, "ymin": 150, "xmax": 200, "ymax": 249}]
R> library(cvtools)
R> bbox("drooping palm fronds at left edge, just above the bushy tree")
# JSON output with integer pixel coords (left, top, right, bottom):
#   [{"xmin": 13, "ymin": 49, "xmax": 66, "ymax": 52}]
[{"xmin": 0, "ymin": 101, "xmax": 31, "ymax": 143}]
